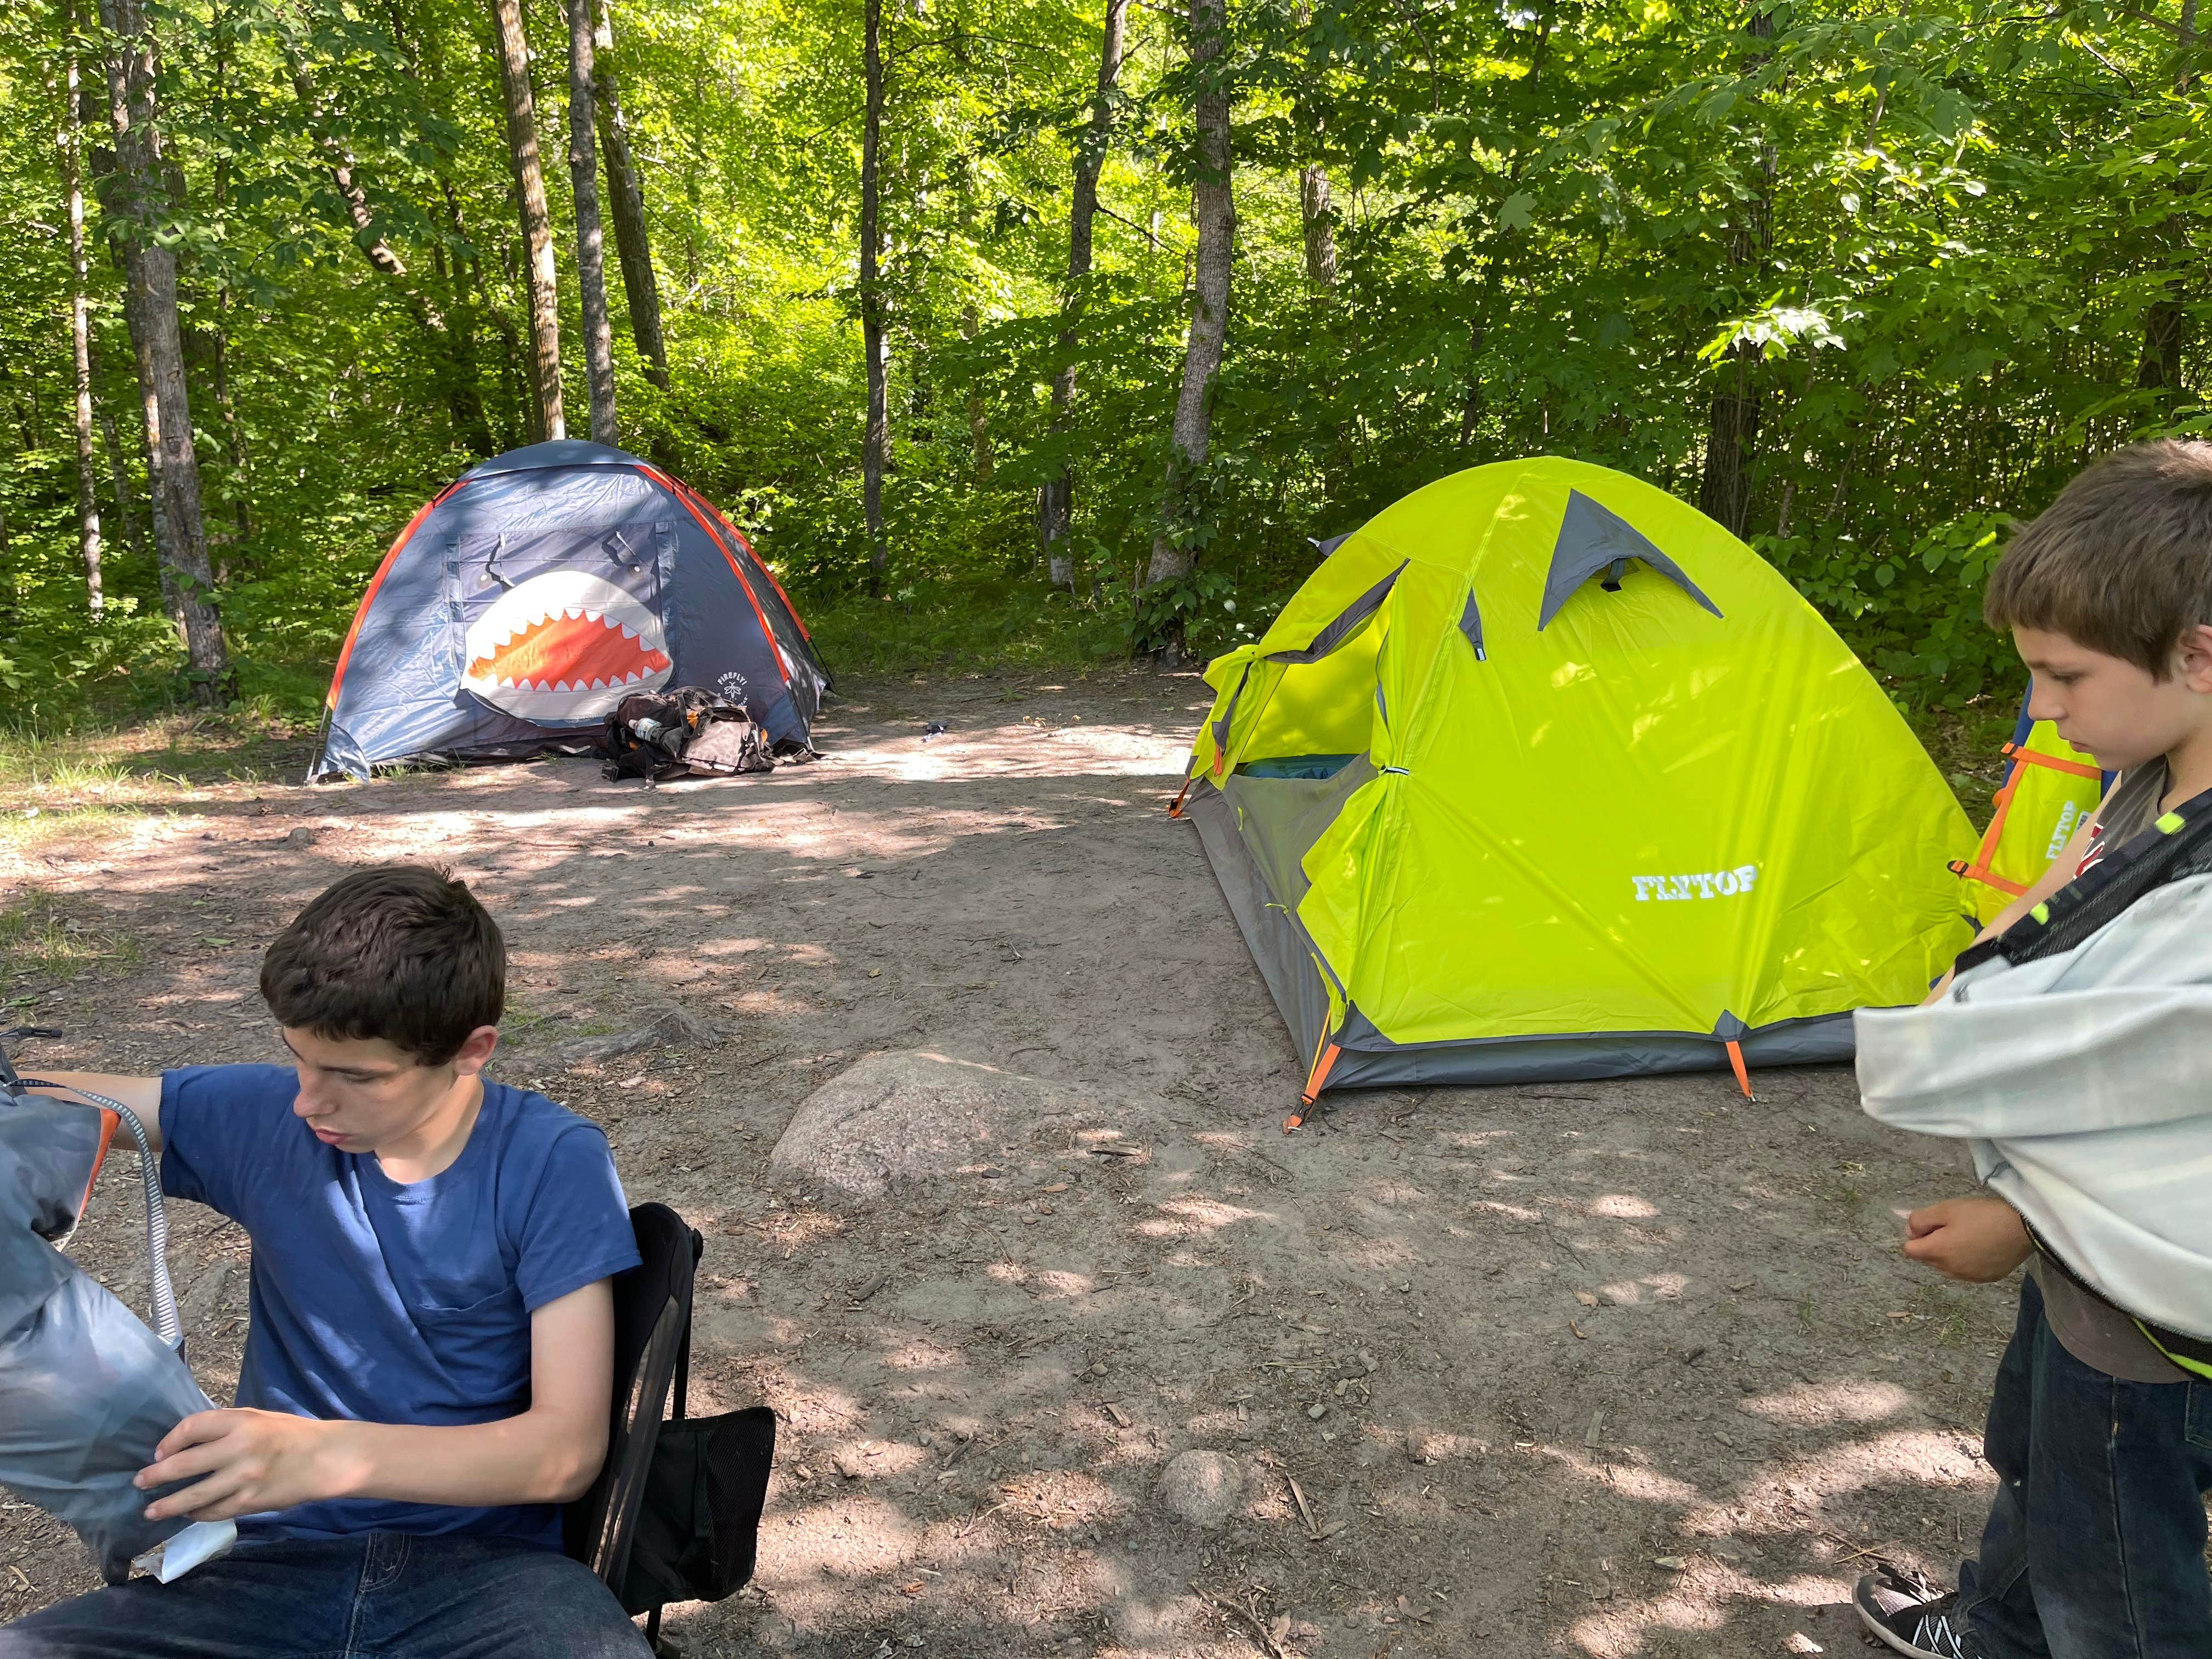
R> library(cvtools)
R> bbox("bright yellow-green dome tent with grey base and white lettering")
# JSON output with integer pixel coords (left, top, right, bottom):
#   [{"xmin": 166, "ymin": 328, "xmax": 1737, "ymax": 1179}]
[{"xmin": 1188, "ymin": 458, "xmax": 1973, "ymax": 1124}]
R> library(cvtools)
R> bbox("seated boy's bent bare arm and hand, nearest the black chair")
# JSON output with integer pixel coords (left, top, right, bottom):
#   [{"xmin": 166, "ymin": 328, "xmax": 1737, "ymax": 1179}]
[{"xmin": 134, "ymin": 1283, "xmax": 615, "ymax": 1520}]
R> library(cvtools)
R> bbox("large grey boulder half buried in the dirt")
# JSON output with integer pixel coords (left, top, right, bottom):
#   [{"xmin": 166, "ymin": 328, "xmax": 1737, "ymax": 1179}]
[{"xmin": 768, "ymin": 1048, "xmax": 1139, "ymax": 1199}]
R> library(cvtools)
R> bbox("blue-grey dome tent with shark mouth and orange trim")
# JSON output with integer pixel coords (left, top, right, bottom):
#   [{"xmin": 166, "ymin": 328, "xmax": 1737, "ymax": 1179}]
[{"xmin": 307, "ymin": 440, "xmax": 830, "ymax": 781}]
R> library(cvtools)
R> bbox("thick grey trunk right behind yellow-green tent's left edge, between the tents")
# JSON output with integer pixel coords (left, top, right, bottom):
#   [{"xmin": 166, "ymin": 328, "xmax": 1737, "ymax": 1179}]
[{"xmin": 1146, "ymin": 0, "xmax": 1237, "ymax": 666}]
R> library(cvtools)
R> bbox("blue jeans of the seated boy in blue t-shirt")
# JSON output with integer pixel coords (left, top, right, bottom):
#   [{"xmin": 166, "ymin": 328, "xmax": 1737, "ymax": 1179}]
[{"xmin": 0, "ymin": 1533, "xmax": 648, "ymax": 1659}]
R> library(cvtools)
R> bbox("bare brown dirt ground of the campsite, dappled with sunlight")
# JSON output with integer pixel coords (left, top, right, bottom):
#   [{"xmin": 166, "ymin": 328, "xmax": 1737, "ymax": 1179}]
[{"xmin": 0, "ymin": 673, "xmax": 2013, "ymax": 1659}]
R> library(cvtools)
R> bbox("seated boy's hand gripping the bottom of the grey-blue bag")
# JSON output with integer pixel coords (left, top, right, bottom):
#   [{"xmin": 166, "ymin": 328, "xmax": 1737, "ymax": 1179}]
[{"xmin": 135, "ymin": 1411, "xmax": 367, "ymax": 1520}]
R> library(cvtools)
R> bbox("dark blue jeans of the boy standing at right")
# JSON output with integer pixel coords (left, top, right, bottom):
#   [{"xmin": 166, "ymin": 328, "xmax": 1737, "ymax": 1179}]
[{"xmin": 1957, "ymin": 1278, "xmax": 2212, "ymax": 1659}]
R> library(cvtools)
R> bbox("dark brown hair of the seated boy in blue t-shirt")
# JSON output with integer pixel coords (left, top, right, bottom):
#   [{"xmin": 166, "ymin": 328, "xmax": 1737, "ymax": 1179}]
[{"xmin": 261, "ymin": 865, "xmax": 506, "ymax": 1066}]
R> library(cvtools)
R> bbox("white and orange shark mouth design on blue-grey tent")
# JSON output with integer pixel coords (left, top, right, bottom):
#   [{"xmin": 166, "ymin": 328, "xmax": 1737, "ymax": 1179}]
[{"xmin": 462, "ymin": 571, "xmax": 675, "ymax": 721}]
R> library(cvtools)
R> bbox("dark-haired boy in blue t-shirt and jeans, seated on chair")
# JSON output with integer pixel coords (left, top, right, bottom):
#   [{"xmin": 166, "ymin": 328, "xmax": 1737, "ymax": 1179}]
[{"xmin": 0, "ymin": 865, "xmax": 646, "ymax": 1659}]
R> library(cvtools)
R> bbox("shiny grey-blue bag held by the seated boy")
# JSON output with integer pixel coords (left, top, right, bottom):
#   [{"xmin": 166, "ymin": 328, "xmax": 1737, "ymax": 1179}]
[{"xmin": 0, "ymin": 1086, "xmax": 236, "ymax": 1584}]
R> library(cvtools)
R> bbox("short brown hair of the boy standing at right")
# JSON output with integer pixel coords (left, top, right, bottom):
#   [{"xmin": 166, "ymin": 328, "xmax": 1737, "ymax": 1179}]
[{"xmin": 1982, "ymin": 438, "xmax": 2212, "ymax": 679}]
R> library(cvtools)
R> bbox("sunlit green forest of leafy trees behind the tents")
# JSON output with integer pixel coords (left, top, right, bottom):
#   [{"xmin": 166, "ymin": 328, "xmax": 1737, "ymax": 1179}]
[{"xmin": 0, "ymin": 0, "xmax": 2212, "ymax": 725}]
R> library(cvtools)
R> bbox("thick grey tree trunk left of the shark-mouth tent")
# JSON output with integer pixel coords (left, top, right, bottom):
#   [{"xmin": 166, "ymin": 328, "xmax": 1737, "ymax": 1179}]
[{"xmin": 99, "ymin": 0, "xmax": 230, "ymax": 701}]
